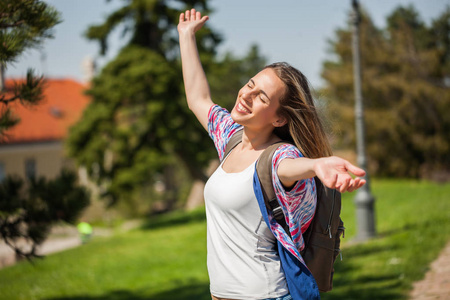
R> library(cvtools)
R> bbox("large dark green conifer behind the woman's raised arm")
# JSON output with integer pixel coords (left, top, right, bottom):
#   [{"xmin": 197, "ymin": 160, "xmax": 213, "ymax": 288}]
[{"xmin": 69, "ymin": 0, "xmax": 268, "ymax": 209}]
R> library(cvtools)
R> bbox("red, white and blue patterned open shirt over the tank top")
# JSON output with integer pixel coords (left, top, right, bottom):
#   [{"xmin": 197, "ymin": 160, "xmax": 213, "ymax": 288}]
[{"xmin": 208, "ymin": 105, "xmax": 317, "ymax": 264}]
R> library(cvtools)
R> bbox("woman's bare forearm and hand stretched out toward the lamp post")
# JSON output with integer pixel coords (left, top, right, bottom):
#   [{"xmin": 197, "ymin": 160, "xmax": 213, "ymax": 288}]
[{"xmin": 277, "ymin": 156, "xmax": 366, "ymax": 193}]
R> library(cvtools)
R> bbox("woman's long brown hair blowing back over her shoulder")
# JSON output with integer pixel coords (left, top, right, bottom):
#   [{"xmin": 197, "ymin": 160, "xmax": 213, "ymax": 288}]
[{"xmin": 264, "ymin": 62, "xmax": 332, "ymax": 158}]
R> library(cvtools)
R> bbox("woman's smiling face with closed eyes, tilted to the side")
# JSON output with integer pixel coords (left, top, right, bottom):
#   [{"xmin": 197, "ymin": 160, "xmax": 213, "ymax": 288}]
[{"xmin": 231, "ymin": 68, "xmax": 285, "ymax": 130}]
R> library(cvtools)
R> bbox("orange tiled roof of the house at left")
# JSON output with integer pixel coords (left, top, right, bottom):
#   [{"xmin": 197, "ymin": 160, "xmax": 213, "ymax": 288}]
[{"xmin": 0, "ymin": 78, "xmax": 89, "ymax": 144}]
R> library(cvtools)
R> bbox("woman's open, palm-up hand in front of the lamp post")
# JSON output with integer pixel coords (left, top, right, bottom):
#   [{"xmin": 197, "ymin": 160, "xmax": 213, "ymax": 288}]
[{"xmin": 313, "ymin": 156, "xmax": 366, "ymax": 193}]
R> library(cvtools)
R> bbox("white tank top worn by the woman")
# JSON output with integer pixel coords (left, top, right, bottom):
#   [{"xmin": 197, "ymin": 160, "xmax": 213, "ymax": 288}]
[{"xmin": 205, "ymin": 158, "xmax": 288, "ymax": 299}]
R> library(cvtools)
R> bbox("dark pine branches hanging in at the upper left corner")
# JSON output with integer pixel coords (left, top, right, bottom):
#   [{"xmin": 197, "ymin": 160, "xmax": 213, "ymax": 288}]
[{"xmin": 0, "ymin": 0, "xmax": 59, "ymax": 141}]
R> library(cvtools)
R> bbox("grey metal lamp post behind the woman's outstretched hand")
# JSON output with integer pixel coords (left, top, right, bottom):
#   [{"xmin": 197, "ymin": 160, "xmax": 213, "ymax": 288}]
[{"xmin": 352, "ymin": 0, "xmax": 375, "ymax": 241}]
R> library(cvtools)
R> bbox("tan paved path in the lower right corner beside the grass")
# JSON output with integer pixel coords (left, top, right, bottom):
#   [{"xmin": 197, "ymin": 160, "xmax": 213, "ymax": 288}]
[{"xmin": 410, "ymin": 243, "xmax": 450, "ymax": 300}]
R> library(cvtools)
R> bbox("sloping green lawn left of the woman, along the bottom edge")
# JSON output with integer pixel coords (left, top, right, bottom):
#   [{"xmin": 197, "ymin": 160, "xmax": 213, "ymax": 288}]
[{"xmin": 0, "ymin": 210, "xmax": 209, "ymax": 300}]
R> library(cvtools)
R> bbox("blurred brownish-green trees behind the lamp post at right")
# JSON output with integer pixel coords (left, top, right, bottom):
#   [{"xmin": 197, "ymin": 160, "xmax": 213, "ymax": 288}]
[{"xmin": 322, "ymin": 6, "xmax": 450, "ymax": 178}]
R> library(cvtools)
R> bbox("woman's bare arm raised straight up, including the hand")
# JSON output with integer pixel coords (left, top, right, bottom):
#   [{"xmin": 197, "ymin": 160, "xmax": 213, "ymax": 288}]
[{"xmin": 177, "ymin": 9, "xmax": 214, "ymax": 129}]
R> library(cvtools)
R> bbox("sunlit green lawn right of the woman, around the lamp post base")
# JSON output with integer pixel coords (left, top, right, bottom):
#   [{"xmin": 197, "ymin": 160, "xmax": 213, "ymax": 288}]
[{"xmin": 322, "ymin": 180, "xmax": 450, "ymax": 300}]
